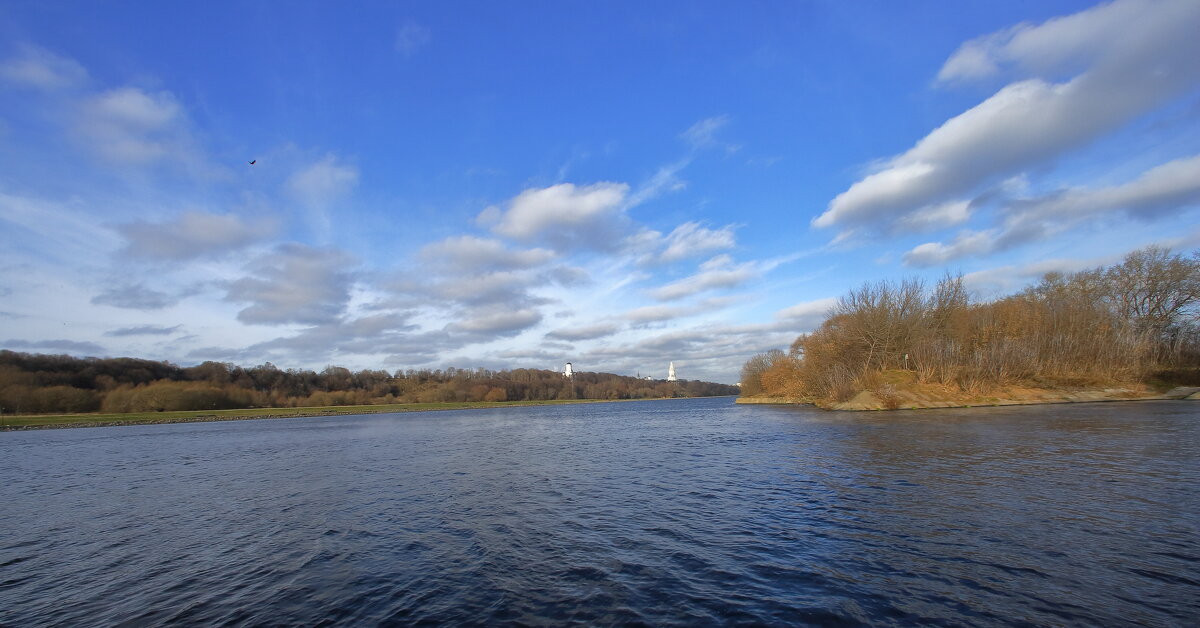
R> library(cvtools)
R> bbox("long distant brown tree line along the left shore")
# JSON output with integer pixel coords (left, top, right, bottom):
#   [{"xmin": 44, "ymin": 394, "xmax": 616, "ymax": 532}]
[{"xmin": 0, "ymin": 351, "xmax": 737, "ymax": 414}]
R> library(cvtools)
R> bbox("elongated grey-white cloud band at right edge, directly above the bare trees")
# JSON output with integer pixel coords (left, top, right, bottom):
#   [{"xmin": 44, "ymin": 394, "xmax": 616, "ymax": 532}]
[{"xmin": 904, "ymin": 155, "xmax": 1200, "ymax": 267}]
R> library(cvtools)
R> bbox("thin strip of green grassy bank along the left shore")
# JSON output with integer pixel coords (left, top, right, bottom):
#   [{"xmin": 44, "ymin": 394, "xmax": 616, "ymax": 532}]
[{"xmin": 0, "ymin": 399, "xmax": 686, "ymax": 431}]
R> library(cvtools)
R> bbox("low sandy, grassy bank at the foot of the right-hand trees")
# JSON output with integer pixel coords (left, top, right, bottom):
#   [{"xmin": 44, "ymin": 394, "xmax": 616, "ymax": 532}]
[{"xmin": 737, "ymin": 384, "xmax": 1200, "ymax": 411}]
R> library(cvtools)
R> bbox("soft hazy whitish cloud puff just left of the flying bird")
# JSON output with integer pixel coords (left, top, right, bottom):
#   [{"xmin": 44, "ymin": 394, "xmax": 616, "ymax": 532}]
[{"xmin": 77, "ymin": 88, "xmax": 188, "ymax": 163}]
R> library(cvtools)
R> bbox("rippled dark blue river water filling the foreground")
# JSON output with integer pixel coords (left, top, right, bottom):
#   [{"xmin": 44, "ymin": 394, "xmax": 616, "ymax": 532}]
[{"xmin": 0, "ymin": 399, "xmax": 1200, "ymax": 626}]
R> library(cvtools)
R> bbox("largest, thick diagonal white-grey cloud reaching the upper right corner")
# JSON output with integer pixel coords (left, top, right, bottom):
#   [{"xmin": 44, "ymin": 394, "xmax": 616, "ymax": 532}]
[{"xmin": 812, "ymin": 0, "xmax": 1200, "ymax": 234}]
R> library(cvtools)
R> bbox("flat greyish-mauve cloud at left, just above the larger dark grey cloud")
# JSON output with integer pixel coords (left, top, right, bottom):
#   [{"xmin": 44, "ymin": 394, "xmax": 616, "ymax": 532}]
[{"xmin": 116, "ymin": 211, "xmax": 277, "ymax": 261}]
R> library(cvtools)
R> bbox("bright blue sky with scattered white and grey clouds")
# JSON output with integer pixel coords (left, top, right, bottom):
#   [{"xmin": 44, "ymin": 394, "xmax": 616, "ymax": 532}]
[{"xmin": 0, "ymin": 0, "xmax": 1200, "ymax": 383}]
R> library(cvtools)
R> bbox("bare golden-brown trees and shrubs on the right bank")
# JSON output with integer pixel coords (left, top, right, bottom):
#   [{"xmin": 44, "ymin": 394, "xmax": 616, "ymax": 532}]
[{"xmin": 742, "ymin": 247, "xmax": 1200, "ymax": 401}]
